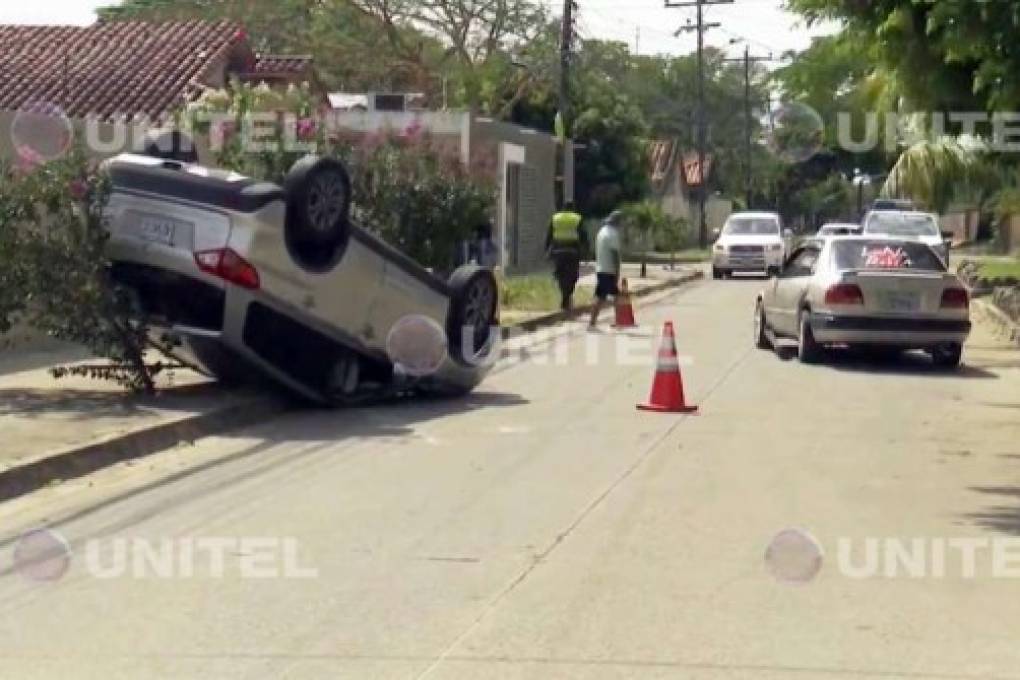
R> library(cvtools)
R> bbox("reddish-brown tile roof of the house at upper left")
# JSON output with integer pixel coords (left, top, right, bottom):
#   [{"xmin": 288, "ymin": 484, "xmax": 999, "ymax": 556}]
[{"xmin": 0, "ymin": 21, "xmax": 247, "ymax": 119}]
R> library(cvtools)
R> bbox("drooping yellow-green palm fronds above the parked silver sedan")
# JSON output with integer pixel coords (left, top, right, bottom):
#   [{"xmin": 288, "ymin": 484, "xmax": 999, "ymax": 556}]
[{"xmin": 881, "ymin": 138, "xmax": 981, "ymax": 214}]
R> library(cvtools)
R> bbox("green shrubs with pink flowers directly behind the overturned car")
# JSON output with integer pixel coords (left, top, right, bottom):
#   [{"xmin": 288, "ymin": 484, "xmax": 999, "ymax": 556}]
[{"xmin": 184, "ymin": 83, "xmax": 496, "ymax": 272}]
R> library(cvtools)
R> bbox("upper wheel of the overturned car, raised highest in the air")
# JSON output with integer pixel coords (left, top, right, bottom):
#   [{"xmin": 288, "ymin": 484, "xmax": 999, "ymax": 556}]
[{"xmin": 284, "ymin": 156, "xmax": 351, "ymax": 247}]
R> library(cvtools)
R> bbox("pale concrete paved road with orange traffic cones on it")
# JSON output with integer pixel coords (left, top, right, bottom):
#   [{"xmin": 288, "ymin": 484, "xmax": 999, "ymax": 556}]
[{"xmin": 0, "ymin": 281, "xmax": 1020, "ymax": 680}]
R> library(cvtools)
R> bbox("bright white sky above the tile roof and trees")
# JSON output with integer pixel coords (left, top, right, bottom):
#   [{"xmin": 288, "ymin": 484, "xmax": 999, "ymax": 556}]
[{"xmin": 0, "ymin": 0, "xmax": 834, "ymax": 57}]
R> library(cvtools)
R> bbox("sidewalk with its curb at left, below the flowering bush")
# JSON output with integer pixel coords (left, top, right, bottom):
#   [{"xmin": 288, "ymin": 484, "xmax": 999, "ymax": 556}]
[{"xmin": 0, "ymin": 360, "xmax": 284, "ymax": 501}]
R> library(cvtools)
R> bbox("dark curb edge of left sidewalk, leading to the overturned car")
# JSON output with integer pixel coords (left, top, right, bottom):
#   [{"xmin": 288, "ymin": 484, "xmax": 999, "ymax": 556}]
[{"xmin": 0, "ymin": 396, "xmax": 288, "ymax": 502}]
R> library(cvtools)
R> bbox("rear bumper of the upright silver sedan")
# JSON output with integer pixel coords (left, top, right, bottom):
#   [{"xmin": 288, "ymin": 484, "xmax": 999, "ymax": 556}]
[{"xmin": 810, "ymin": 313, "xmax": 972, "ymax": 348}]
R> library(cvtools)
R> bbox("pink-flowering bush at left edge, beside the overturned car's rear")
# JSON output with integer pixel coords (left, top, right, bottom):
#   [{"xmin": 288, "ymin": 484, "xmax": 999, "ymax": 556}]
[{"xmin": 0, "ymin": 150, "xmax": 180, "ymax": 390}]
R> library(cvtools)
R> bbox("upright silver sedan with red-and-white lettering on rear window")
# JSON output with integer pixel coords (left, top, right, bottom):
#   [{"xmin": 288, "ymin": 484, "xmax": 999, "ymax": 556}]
[{"xmin": 754, "ymin": 237, "xmax": 971, "ymax": 367}]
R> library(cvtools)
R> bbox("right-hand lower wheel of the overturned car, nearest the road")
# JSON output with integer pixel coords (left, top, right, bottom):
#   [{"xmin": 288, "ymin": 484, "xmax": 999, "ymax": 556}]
[{"xmin": 447, "ymin": 265, "xmax": 500, "ymax": 365}]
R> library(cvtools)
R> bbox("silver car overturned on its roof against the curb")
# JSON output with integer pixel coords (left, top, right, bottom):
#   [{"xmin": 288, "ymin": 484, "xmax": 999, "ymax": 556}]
[{"xmin": 106, "ymin": 154, "xmax": 499, "ymax": 404}]
